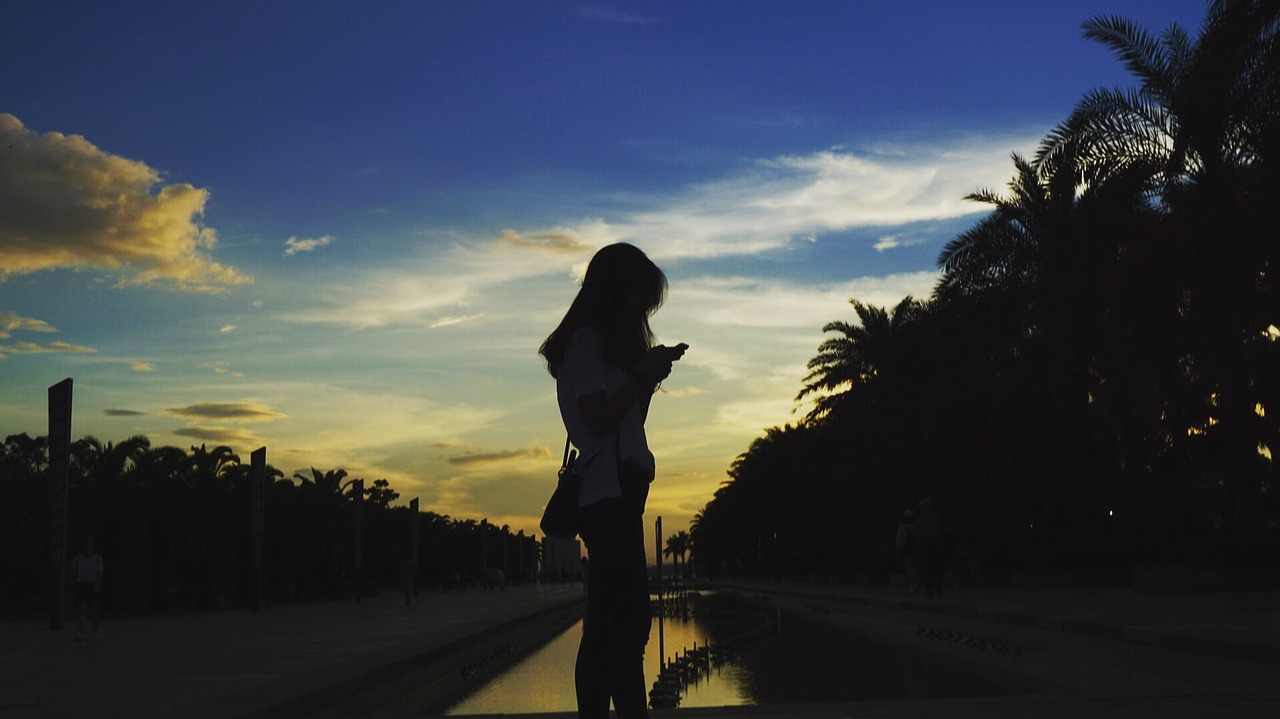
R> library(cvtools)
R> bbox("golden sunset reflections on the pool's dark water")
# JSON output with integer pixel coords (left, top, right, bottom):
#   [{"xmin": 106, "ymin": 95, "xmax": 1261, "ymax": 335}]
[{"xmin": 445, "ymin": 603, "xmax": 750, "ymax": 716}]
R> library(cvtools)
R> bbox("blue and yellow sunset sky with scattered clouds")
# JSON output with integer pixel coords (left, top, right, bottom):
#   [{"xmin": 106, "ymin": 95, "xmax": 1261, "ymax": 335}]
[{"xmin": 0, "ymin": 0, "xmax": 1203, "ymax": 544}]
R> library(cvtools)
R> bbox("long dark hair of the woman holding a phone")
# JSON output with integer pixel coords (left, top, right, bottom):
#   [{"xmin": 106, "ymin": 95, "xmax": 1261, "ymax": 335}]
[{"xmin": 538, "ymin": 242, "xmax": 667, "ymax": 377}]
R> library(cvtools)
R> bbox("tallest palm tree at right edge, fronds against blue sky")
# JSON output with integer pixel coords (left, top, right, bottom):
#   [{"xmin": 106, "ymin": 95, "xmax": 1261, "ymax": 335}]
[{"xmin": 1037, "ymin": 0, "xmax": 1280, "ymax": 540}]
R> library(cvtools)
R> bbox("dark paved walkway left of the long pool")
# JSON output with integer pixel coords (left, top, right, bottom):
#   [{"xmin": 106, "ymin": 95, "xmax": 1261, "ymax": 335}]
[{"xmin": 0, "ymin": 585, "xmax": 584, "ymax": 719}]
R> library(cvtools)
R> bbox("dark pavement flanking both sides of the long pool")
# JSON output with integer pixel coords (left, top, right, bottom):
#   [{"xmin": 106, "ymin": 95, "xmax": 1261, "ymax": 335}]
[{"xmin": 0, "ymin": 575, "xmax": 1280, "ymax": 719}]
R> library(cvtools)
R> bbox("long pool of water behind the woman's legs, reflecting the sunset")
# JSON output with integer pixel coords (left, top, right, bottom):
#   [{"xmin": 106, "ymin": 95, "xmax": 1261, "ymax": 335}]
[{"xmin": 435, "ymin": 592, "xmax": 1029, "ymax": 716}]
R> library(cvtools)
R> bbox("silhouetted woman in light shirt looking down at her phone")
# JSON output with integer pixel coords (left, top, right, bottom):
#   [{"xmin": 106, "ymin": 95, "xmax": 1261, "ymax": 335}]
[{"xmin": 540, "ymin": 243, "xmax": 686, "ymax": 719}]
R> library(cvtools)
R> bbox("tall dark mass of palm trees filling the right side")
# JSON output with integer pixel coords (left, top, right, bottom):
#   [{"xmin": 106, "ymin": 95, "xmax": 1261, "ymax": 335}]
[{"xmin": 691, "ymin": 0, "xmax": 1280, "ymax": 573}]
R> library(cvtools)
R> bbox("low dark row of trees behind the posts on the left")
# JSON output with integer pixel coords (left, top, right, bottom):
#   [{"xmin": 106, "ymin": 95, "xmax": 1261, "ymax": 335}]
[{"xmin": 0, "ymin": 434, "xmax": 539, "ymax": 613}]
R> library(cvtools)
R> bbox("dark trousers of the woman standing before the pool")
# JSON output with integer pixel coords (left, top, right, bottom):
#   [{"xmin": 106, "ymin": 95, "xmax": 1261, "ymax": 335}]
[{"xmin": 573, "ymin": 464, "xmax": 650, "ymax": 719}]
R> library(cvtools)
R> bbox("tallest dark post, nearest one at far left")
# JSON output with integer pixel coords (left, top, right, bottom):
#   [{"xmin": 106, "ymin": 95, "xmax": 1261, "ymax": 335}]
[{"xmin": 49, "ymin": 377, "xmax": 72, "ymax": 629}]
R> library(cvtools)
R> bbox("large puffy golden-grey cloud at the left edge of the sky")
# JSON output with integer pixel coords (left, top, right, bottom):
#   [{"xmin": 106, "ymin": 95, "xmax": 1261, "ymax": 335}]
[{"xmin": 0, "ymin": 114, "xmax": 251, "ymax": 292}]
